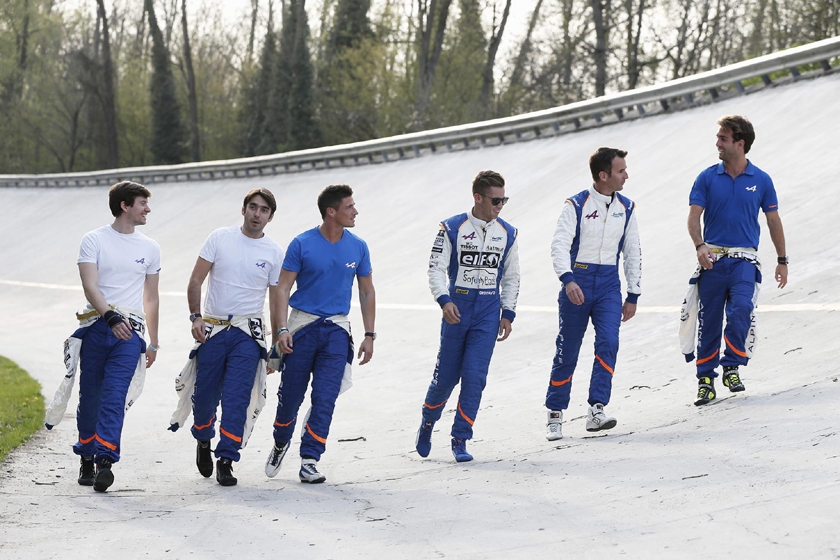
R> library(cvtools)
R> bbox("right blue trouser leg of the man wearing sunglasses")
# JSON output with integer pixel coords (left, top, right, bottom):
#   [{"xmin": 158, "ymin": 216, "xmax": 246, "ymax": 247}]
[{"xmin": 452, "ymin": 308, "xmax": 499, "ymax": 439}]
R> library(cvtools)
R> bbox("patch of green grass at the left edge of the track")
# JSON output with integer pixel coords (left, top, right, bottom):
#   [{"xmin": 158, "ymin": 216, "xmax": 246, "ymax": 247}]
[{"xmin": 0, "ymin": 356, "xmax": 44, "ymax": 461}]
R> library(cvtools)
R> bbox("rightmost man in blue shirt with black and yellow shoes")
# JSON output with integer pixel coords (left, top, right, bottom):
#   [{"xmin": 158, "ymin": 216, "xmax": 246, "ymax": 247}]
[{"xmin": 688, "ymin": 115, "xmax": 788, "ymax": 406}]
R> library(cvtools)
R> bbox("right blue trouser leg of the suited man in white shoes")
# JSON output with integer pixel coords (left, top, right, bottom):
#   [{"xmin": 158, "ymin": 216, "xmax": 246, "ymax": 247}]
[{"xmin": 588, "ymin": 285, "xmax": 621, "ymax": 406}]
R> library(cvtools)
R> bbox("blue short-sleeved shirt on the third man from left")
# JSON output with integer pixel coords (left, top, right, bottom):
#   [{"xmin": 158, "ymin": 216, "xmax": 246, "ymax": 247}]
[{"xmin": 283, "ymin": 227, "xmax": 373, "ymax": 317}]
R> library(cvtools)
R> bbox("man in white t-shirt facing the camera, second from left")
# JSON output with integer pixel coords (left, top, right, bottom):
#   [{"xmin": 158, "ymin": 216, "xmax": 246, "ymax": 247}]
[{"xmin": 187, "ymin": 188, "xmax": 283, "ymax": 486}]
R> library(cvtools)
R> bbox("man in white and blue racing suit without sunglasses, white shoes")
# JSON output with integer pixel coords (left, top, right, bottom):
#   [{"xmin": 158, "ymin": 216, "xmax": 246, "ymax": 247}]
[{"xmin": 545, "ymin": 148, "xmax": 642, "ymax": 441}]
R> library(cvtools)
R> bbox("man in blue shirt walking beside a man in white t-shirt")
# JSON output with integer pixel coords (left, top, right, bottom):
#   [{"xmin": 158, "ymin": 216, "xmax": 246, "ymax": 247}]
[{"xmin": 265, "ymin": 185, "xmax": 376, "ymax": 483}]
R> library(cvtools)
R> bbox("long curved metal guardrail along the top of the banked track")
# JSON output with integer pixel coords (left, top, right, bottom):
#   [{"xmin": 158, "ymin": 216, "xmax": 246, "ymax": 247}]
[{"xmin": 0, "ymin": 37, "xmax": 840, "ymax": 187}]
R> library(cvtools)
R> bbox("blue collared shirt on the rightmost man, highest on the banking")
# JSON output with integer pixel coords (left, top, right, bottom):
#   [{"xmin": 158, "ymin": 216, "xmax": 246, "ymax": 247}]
[{"xmin": 688, "ymin": 161, "xmax": 779, "ymax": 249}]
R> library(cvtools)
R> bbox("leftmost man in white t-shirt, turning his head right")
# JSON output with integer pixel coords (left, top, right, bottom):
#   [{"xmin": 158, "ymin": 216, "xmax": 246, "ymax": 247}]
[{"xmin": 70, "ymin": 181, "xmax": 160, "ymax": 492}]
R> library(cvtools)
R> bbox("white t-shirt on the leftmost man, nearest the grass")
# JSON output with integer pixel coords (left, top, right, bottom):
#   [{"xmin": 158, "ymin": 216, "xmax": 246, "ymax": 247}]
[{"xmin": 76, "ymin": 225, "xmax": 160, "ymax": 309}]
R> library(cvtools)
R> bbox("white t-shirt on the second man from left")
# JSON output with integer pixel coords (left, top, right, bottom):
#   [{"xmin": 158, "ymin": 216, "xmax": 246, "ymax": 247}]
[{"xmin": 198, "ymin": 226, "xmax": 284, "ymax": 316}]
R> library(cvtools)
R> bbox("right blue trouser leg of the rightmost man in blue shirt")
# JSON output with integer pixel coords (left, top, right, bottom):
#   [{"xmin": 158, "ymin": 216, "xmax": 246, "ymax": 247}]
[{"xmin": 720, "ymin": 259, "xmax": 757, "ymax": 372}]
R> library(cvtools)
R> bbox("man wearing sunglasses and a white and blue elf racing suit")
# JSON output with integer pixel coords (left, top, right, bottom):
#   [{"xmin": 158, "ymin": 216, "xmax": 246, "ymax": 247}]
[{"xmin": 416, "ymin": 171, "xmax": 519, "ymax": 462}]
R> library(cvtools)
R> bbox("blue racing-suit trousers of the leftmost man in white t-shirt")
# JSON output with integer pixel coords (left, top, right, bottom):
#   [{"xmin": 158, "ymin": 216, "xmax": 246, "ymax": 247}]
[{"xmin": 73, "ymin": 320, "xmax": 143, "ymax": 463}]
